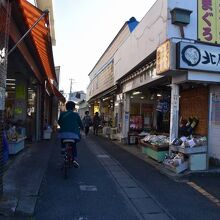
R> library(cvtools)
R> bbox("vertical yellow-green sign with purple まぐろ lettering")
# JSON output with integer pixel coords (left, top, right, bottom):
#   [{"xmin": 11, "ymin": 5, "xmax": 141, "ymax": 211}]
[{"xmin": 198, "ymin": 0, "xmax": 220, "ymax": 44}]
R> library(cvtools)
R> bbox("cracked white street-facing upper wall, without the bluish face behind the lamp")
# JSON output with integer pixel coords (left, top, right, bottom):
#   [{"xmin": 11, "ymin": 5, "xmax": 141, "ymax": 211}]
[{"xmin": 114, "ymin": 0, "xmax": 167, "ymax": 81}]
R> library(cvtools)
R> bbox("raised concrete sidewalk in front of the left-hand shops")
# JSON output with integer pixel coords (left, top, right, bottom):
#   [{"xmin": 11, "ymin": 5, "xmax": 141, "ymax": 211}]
[{"xmin": 0, "ymin": 139, "xmax": 57, "ymax": 216}]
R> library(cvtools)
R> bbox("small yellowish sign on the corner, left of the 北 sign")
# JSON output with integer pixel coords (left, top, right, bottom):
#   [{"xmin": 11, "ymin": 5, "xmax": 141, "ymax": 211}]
[{"xmin": 156, "ymin": 41, "xmax": 170, "ymax": 74}]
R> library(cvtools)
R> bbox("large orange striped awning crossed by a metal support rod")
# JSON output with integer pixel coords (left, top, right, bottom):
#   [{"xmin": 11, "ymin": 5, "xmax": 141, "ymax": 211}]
[{"xmin": 18, "ymin": 0, "xmax": 57, "ymax": 82}]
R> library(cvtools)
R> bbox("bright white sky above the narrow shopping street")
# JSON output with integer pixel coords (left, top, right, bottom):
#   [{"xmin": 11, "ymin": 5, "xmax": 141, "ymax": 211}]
[{"xmin": 31, "ymin": 0, "xmax": 156, "ymax": 92}]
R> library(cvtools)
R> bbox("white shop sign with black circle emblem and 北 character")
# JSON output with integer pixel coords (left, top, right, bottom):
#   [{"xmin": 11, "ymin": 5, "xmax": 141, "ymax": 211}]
[{"xmin": 177, "ymin": 42, "xmax": 220, "ymax": 72}]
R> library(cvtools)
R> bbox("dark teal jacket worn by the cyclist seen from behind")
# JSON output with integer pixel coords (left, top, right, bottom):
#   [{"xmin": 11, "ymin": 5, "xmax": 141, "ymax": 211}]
[{"xmin": 58, "ymin": 111, "xmax": 83, "ymax": 135}]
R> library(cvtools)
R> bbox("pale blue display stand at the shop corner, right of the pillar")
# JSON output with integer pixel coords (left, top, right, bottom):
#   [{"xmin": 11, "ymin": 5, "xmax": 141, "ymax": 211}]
[{"xmin": 170, "ymin": 146, "xmax": 208, "ymax": 171}]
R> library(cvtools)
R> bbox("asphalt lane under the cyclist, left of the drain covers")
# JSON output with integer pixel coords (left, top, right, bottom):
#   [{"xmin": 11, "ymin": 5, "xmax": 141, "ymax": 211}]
[{"xmin": 33, "ymin": 137, "xmax": 141, "ymax": 220}]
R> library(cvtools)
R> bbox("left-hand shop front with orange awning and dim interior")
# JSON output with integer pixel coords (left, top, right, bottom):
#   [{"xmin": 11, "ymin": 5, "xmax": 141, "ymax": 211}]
[{"xmin": 5, "ymin": 1, "xmax": 63, "ymax": 151}]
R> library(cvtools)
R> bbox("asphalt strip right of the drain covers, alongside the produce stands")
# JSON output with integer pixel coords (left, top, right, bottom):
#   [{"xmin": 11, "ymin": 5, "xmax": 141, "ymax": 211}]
[{"xmin": 93, "ymin": 137, "xmax": 220, "ymax": 220}]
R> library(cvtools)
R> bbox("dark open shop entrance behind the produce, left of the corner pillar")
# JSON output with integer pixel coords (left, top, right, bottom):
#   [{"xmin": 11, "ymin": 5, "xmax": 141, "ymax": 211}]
[{"xmin": 129, "ymin": 88, "xmax": 170, "ymax": 133}]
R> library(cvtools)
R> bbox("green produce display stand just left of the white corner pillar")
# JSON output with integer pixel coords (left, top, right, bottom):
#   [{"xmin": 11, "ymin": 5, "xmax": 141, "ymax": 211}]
[{"xmin": 141, "ymin": 141, "xmax": 169, "ymax": 162}]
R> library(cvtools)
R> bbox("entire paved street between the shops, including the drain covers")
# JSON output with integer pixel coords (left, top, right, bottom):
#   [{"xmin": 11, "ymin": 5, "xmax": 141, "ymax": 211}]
[{"xmin": 0, "ymin": 136, "xmax": 220, "ymax": 220}]
